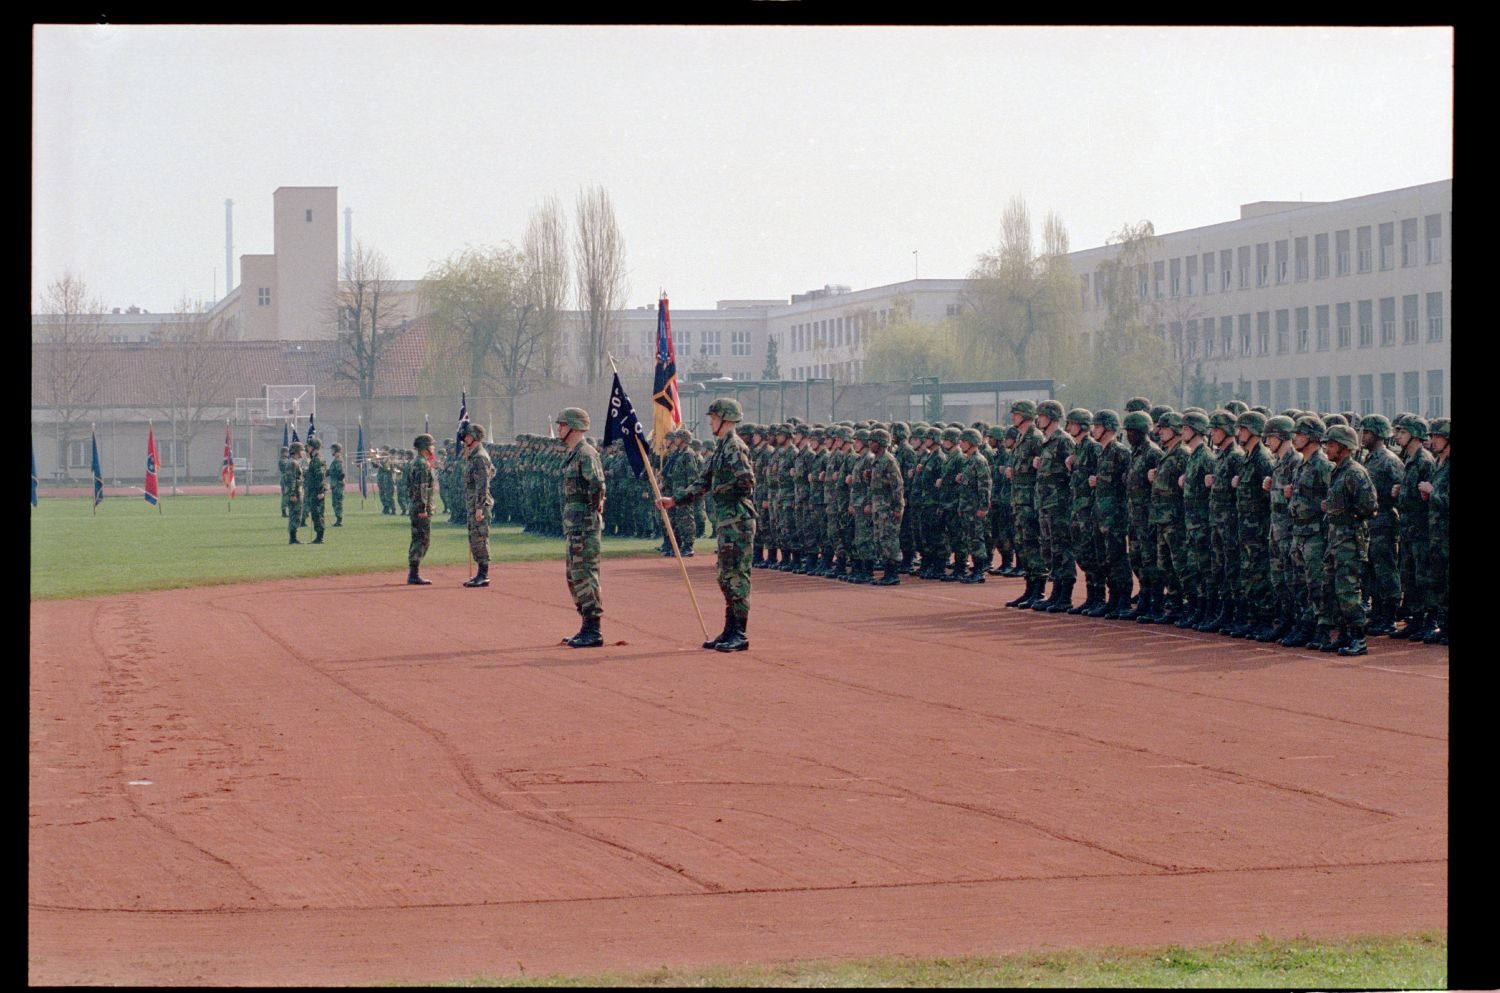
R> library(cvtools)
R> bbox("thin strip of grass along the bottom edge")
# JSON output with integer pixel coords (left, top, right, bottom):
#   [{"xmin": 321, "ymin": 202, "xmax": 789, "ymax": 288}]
[{"xmin": 417, "ymin": 932, "xmax": 1448, "ymax": 990}]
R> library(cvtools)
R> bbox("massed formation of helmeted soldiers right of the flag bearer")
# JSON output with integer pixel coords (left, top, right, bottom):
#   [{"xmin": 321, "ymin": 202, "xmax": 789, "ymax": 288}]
[{"xmin": 740, "ymin": 398, "xmax": 1452, "ymax": 656}]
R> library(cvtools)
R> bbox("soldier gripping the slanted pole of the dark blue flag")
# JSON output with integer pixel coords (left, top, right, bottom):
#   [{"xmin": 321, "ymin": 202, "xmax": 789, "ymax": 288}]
[{"xmin": 657, "ymin": 396, "xmax": 756, "ymax": 651}]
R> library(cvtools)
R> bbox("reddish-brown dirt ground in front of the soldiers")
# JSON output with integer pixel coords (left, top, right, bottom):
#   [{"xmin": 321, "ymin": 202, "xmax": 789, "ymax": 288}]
[{"xmin": 29, "ymin": 557, "xmax": 1449, "ymax": 986}]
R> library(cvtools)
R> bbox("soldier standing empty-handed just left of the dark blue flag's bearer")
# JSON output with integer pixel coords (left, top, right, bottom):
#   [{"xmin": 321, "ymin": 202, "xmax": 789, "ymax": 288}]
[{"xmin": 555, "ymin": 407, "xmax": 603, "ymax": 648}]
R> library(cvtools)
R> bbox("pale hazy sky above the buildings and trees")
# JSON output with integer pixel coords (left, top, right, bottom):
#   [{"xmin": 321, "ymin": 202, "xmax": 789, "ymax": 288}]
[{"xmin": 32, "ymin": 26, "xmax": 1454, "ymax": 312}]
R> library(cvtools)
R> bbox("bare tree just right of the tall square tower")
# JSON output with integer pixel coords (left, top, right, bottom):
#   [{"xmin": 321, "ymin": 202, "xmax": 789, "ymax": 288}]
[{"xmin": 333, "ymin": 242, "xmax": 407, "ymax": 425}]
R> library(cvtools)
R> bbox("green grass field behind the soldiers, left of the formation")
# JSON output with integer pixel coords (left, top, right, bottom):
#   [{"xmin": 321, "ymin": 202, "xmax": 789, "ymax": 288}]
[{"xmin": 32, "ymin": 494, "xmax": 656, "ymax": 600}]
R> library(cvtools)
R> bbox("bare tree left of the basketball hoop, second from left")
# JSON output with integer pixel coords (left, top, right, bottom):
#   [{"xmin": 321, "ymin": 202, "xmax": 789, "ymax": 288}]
[{"xmin": 156, "ymin": 300, "xmax": 234, "ymax": 489}]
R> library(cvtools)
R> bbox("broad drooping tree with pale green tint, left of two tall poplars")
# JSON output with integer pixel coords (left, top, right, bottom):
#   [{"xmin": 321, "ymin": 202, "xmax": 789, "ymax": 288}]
[{"xmin": 423, "ymin": 245, "xmax": 543, "ymax": 429}]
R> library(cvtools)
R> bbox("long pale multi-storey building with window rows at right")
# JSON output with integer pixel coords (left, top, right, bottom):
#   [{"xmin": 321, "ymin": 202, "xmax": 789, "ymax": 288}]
[{"xmin": 1070, "ymin": 180, "xmax": 1454, "ymax": 417}]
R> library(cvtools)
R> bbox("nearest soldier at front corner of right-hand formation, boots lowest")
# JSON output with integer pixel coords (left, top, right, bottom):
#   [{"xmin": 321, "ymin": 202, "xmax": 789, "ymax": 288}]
[{"xmin": 1322, "ymin": 425, "xmax": 1380, "ymax": 656}]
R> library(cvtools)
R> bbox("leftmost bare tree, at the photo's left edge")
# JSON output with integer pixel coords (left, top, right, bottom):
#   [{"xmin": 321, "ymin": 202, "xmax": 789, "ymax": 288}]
[{"xmin": 32, "ymin": 273, "xmax": 105, "ymax": 473}]
